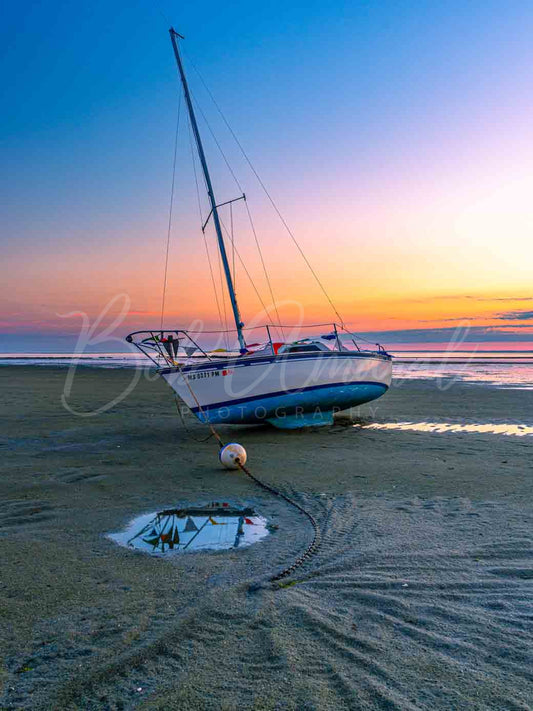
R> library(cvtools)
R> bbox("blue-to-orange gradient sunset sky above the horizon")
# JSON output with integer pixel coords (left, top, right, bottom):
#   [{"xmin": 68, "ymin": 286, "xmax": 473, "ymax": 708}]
[{"xmin": 0, "ymin": 0, "xmax": 533, "ymax": 352}]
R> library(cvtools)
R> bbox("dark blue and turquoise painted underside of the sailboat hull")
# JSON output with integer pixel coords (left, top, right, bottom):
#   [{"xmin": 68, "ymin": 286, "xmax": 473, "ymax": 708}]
[{"xmin": 193, "ymin": 382, "xmax": 387, "ymax": 428}]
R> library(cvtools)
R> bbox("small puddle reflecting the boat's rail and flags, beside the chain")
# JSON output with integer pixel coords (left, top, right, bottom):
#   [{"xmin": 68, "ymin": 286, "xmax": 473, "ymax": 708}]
[{"xmin": 108, "ymin": 502, "xmax": 268, "ymax": 556}]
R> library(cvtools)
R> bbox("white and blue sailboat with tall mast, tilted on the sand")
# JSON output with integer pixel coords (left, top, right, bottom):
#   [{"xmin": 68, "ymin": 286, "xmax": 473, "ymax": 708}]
[{"xmin": 126, "ymin": 28, "xmax": 392, "ymax": 429}]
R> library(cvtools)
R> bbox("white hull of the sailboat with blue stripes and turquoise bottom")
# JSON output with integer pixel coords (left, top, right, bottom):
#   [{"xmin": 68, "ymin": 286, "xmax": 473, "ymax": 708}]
[{"xmin": 161, "ymin": 352, "xmax": 392, "ymax": 429}]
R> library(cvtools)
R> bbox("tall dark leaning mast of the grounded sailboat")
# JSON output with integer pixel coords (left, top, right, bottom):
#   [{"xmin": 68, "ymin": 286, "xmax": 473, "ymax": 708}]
[{"xmin": 169, "ymin": 27, "xmax": 246, "ymax": 351}]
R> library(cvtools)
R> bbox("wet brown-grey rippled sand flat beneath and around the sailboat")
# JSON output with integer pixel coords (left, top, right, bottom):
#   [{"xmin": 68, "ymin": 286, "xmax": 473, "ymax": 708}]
[{"xmin": 0, "ymin": 367, "xmax": 533, "ymax": 711}]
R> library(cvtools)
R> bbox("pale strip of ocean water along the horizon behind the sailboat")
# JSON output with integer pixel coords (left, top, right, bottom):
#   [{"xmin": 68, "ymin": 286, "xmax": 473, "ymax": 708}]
[{"xmin": 0, "ymin": 344, "xmax": 533, "ymax": 389}]
